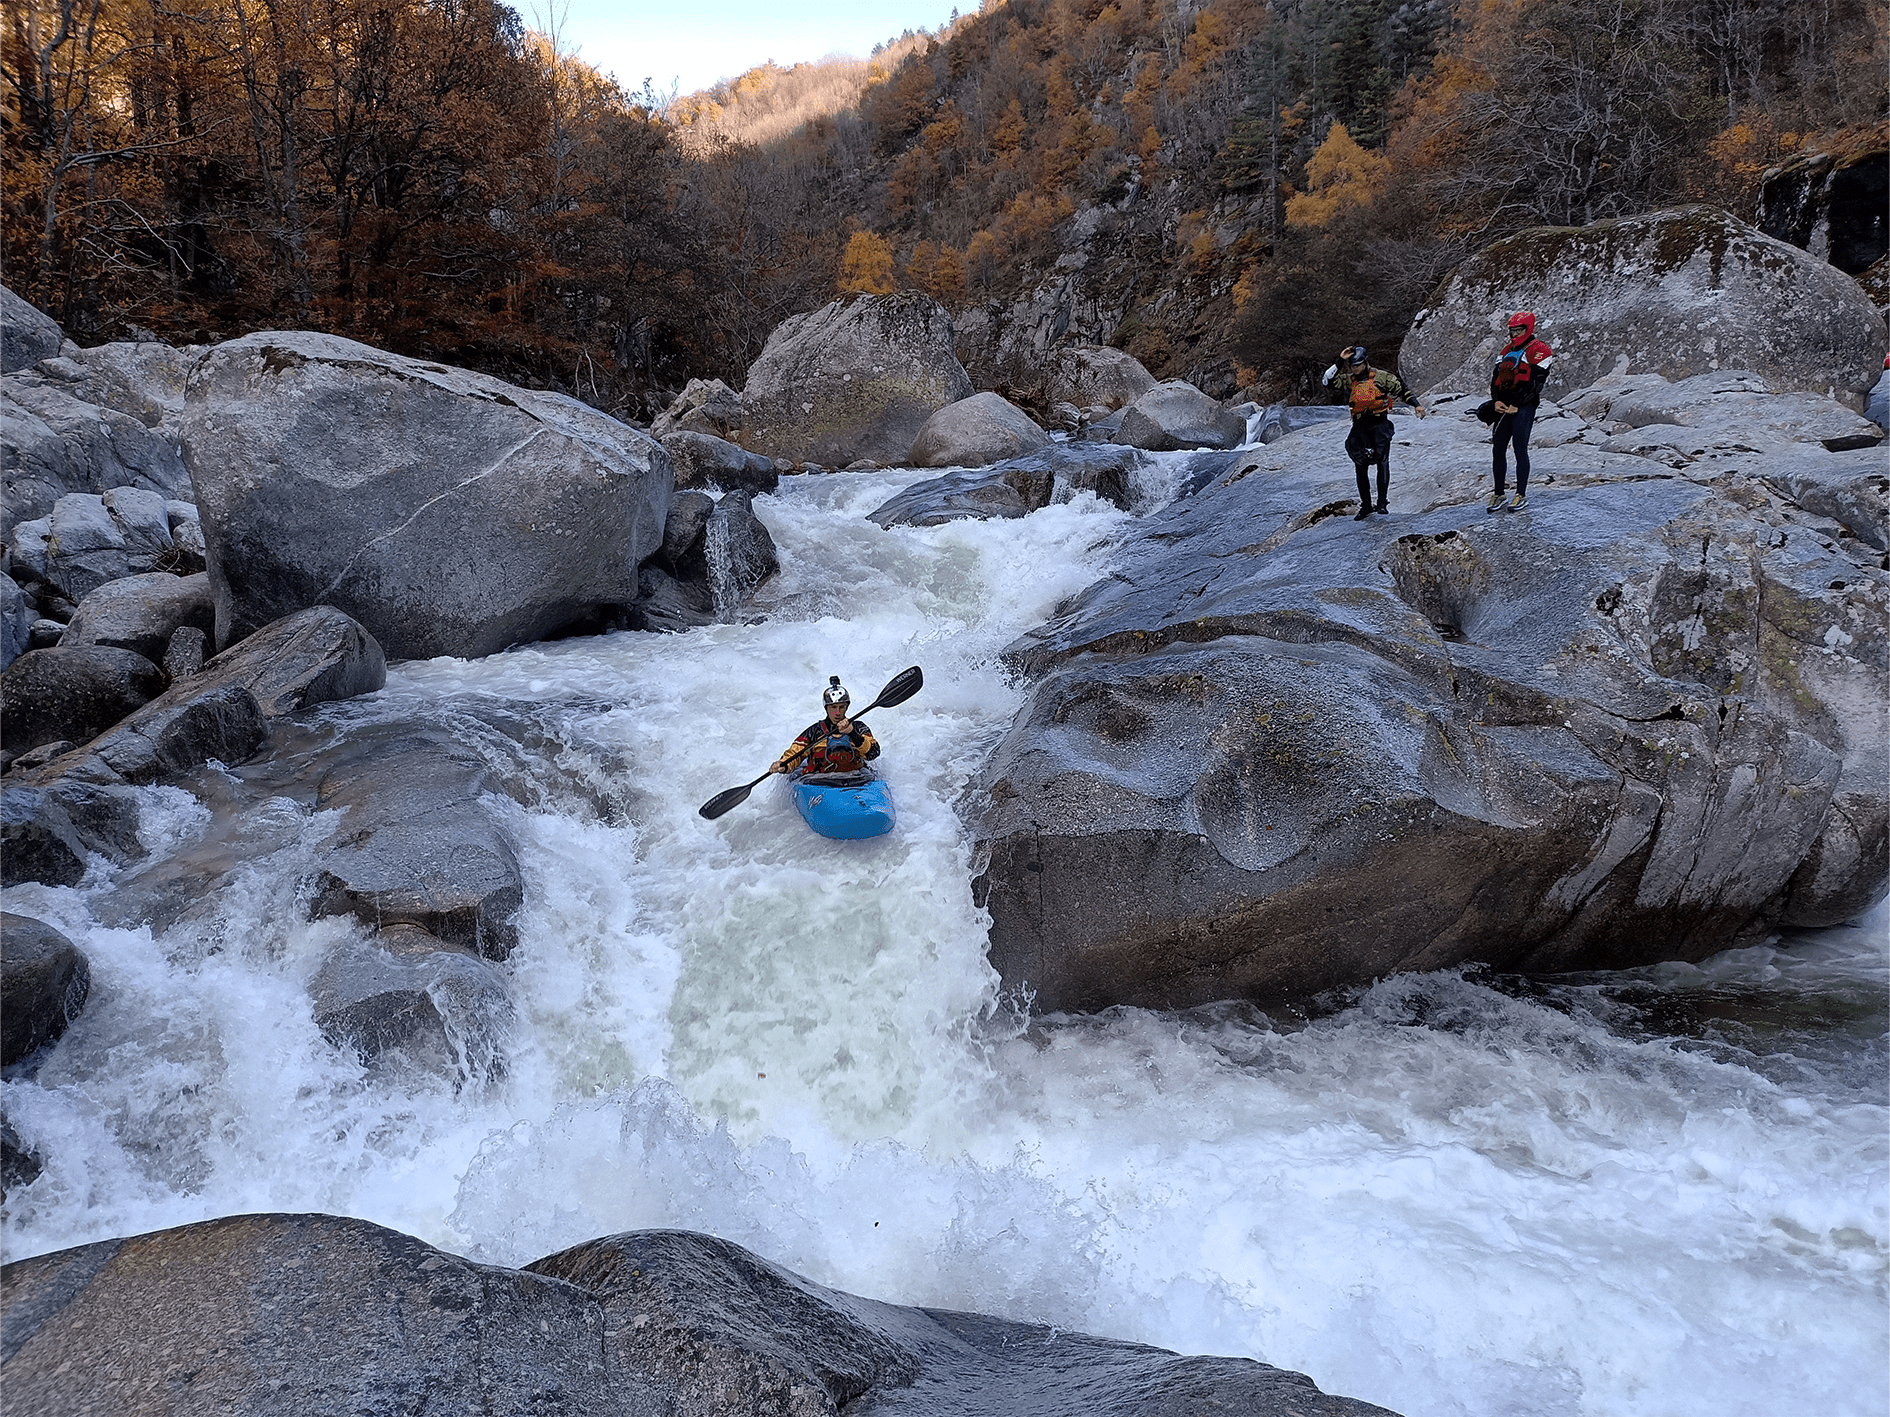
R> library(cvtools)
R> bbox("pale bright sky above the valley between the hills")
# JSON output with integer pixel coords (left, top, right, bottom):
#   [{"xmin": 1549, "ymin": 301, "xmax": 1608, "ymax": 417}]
[{"xmin": 536, "ymin": 0, "xmax": 977, "ymax": 93}]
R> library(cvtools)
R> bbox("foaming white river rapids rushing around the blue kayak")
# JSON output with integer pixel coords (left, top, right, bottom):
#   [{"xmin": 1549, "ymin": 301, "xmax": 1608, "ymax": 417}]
[{"xmin": 0, "ymin": 472, "xmax": 1890, "ymax": 1417}]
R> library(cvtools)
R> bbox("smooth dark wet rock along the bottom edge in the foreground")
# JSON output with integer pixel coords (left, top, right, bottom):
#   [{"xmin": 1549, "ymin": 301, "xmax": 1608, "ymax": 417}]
[{"xmin": 0, "ymin": 1215, "xmax": 1391, "ymax": 1417}]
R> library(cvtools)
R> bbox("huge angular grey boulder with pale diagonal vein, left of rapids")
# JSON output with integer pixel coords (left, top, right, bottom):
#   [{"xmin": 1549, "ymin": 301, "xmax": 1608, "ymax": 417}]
[{"xmin": 181, "ymin": 333, "xmax": 671, "ymax": 659}]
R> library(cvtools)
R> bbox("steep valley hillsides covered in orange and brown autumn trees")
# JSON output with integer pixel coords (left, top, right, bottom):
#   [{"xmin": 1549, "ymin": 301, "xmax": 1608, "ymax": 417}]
[{"xmin": 0, "ymin": 0, "xmax": 1886, "ymax": 416}]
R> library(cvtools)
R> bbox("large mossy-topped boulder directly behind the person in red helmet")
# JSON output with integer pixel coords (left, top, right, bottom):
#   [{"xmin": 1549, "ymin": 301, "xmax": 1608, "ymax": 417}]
[{"xmin": 1399, "ymin": 206, "xmax": 1890, "ymax": 408}]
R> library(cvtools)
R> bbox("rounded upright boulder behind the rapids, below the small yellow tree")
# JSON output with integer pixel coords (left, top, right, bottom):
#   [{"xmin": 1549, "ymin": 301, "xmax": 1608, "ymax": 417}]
[{"xmin": 741, "ymin": 295, "xmax": 973, "ymax": 467}]
